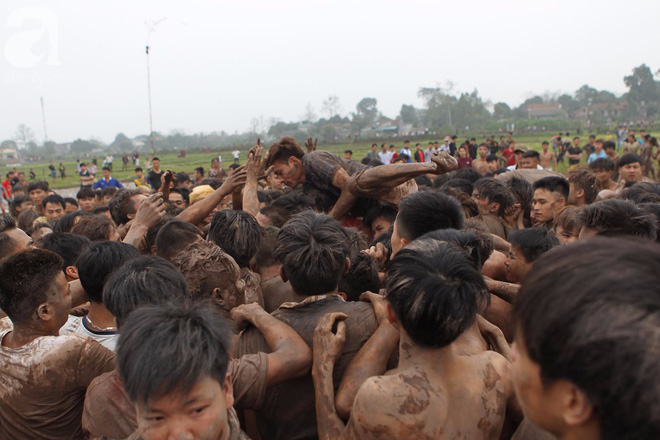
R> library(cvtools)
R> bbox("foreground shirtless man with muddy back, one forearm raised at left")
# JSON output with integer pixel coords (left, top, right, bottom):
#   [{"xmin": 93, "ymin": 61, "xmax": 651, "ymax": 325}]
[{"xmin": 312, "ymin": 238, "xmax": 514, "ymax": 440}]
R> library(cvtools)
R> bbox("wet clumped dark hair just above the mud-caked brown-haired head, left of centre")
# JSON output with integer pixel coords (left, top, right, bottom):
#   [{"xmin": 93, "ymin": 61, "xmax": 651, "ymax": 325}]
[{"xmin": 207, "ymin": 210, "xmax": 261, "ymax": 267}]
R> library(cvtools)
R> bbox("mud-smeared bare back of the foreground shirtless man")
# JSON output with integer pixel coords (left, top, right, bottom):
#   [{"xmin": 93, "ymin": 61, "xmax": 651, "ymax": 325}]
[{"xmin": 346, "ymin": 352, "xmax": 513, "ymax": 440}]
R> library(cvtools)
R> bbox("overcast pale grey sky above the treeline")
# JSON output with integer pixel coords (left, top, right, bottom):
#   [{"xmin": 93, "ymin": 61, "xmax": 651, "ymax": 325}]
[{"xmin": 0, "ymin": 0, "xmax": 660, "ymax": 142}]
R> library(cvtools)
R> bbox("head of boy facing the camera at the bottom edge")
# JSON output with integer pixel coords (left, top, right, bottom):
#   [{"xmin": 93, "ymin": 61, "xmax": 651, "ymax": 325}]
[{"xmin": 117, "ymin": 305, "xmax": 234, "ymax": 440}]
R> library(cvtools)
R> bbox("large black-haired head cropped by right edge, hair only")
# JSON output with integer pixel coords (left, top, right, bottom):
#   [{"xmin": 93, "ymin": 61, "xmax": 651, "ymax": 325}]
[{"xmin": 514, "ymin": 237, "xmax": 660, "ymax": 440}]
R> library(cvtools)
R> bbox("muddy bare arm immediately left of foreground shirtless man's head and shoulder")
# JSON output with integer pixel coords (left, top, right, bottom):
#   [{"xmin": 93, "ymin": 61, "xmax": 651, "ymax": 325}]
[{"xmin": 335, "ymin": 292, "xmax": 399, "ymax": 420}]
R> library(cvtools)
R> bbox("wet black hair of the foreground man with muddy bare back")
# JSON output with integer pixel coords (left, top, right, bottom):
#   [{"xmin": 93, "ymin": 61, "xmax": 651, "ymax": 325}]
[{"xmin": 386, "ymin": 238, "xmax": 486, "ymax": 348}]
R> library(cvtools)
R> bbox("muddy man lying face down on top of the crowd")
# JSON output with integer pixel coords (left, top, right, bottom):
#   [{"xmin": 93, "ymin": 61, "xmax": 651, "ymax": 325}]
[{"xmin": 265, "ymin": 137, "xmax": 458, "ymax": 219}]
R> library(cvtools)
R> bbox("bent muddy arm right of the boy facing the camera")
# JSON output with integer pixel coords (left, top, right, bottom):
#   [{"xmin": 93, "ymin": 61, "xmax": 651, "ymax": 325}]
[{"xmin": 231, "ymin": 303, "xmax": 312, "ymax": 386}]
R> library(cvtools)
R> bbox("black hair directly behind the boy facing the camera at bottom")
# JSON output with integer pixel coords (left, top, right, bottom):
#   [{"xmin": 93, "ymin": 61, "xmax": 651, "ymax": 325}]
[{"xmin": 103, "ymin": 255, "xmax": 188, "ymax": 325}]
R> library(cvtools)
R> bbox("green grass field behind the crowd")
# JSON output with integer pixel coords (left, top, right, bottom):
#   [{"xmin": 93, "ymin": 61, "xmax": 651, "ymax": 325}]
[{"xmin": 0, "ymin": 132, "xmax": 620, "ymax": 189}]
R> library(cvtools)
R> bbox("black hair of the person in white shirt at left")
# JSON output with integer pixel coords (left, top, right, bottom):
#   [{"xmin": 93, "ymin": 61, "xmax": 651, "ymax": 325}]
[{"xmin": 76, "ymin": 241, "xmax": 140, "ymax": 303}]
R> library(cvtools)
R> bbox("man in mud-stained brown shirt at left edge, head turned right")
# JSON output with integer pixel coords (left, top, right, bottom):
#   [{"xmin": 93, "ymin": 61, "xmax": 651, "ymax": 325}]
[{"xmin": 0, "ymin": 249, "xmax": 115, "ymax": 439}]
